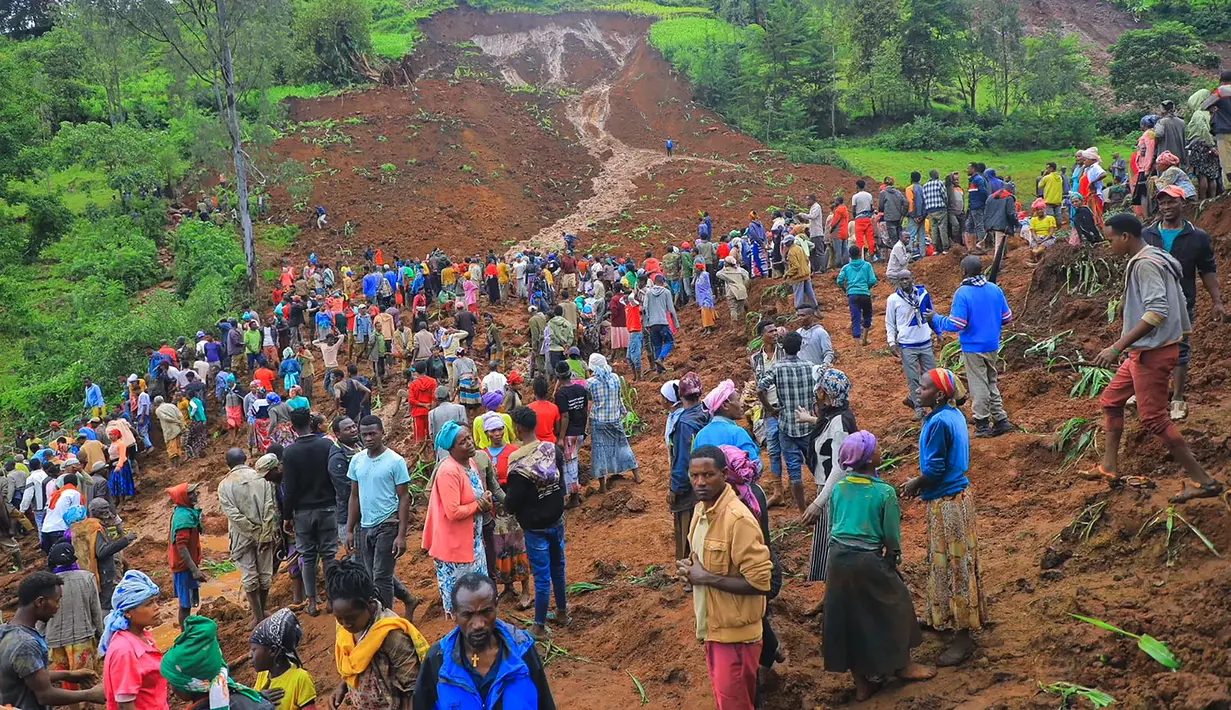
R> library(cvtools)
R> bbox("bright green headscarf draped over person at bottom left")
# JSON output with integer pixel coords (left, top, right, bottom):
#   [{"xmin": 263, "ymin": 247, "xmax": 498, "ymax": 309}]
[{"xmin": 162, "ymin": 616, "xmax": 263, "ymax": 710}]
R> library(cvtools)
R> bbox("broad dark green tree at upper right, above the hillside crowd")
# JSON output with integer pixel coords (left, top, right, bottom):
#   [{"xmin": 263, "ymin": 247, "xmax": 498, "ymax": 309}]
[{"xmin": 1109, "ymin": 22, "xmax": 1217, "ymax": 106}]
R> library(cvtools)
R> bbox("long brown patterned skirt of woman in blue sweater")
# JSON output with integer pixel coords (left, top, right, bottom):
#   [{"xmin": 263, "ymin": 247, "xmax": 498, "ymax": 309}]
[{"xmin": 923, "ymin": 489, "xmax": 987, "ymax": 631}]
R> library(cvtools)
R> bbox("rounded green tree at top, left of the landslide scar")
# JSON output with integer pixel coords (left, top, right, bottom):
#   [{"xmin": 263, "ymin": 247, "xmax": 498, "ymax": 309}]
[{"xmin": 293, "ymin": 0, "xmax": 372, "ymax": 86}]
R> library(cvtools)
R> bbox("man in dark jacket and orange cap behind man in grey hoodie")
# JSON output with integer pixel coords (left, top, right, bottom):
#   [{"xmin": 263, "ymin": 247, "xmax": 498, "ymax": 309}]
[{"xmin": 1141, "ymin": 185, "xmax": 1227, "ymax": 420}]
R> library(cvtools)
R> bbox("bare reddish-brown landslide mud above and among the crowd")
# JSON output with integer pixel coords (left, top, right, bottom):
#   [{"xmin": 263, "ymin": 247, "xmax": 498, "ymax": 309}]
[{"xmin": 7, "ymin": 10, "xmax": 1231, "ymax": 710}]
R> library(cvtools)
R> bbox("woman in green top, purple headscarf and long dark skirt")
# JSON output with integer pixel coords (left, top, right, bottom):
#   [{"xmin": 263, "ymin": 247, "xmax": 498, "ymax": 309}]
[{"xmin": 821, "ymin": 432, "xmax": 936, "ymax": 701}]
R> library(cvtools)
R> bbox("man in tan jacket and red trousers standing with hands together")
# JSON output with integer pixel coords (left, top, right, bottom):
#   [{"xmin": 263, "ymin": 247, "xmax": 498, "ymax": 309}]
[{"xmin": 676, "ymin": 447, "xmax": 773, "ymax": 710}]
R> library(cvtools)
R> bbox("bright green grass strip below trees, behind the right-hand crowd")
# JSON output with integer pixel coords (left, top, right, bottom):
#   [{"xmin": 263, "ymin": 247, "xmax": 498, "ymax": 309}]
[{"xmin": 837, "ymin": 139, "xmax": 1133, "ymax": 185}]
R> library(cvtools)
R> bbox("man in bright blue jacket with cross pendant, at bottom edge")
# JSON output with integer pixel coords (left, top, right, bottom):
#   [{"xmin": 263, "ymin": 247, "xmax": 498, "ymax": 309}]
[{"xmin": 411, "ymin": 572, "xmax": 555, "ymax": 710}]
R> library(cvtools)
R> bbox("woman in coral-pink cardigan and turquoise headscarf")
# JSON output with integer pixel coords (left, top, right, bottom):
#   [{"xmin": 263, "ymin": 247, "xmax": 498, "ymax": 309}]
[{"xmin": 423, "ymin": 422, "xmax": 491, "ymax": 619}]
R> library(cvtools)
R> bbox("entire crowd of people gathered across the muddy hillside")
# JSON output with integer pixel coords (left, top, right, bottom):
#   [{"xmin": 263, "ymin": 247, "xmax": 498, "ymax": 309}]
[{"xmin": 0, "ymin": 74, "xmax": 1231, "ymax": 710}]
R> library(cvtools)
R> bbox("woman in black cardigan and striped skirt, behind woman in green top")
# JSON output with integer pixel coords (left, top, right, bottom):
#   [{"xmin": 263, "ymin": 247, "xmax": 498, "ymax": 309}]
[{"xmin": 800, "ymin": 368, "xmax": 859, "ymax": 615}]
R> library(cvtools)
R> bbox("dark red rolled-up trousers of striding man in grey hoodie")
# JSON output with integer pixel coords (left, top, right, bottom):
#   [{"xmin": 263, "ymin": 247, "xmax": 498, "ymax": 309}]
[{"xmin": 1098, "ymin": 343, "xmax": 1182, "ymax": 443}]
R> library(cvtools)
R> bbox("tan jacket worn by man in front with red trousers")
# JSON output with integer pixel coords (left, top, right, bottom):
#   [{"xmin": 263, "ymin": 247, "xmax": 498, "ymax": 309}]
[{"xmin": 688, "ymin": 486, "xmax": 773, "ymax": 644}]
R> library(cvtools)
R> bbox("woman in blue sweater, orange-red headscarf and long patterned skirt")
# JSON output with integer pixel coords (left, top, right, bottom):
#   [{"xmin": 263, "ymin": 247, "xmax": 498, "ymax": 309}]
[{"xmin": 902, "ymin": 368, "xmax": 987, "ymax": 666}]
